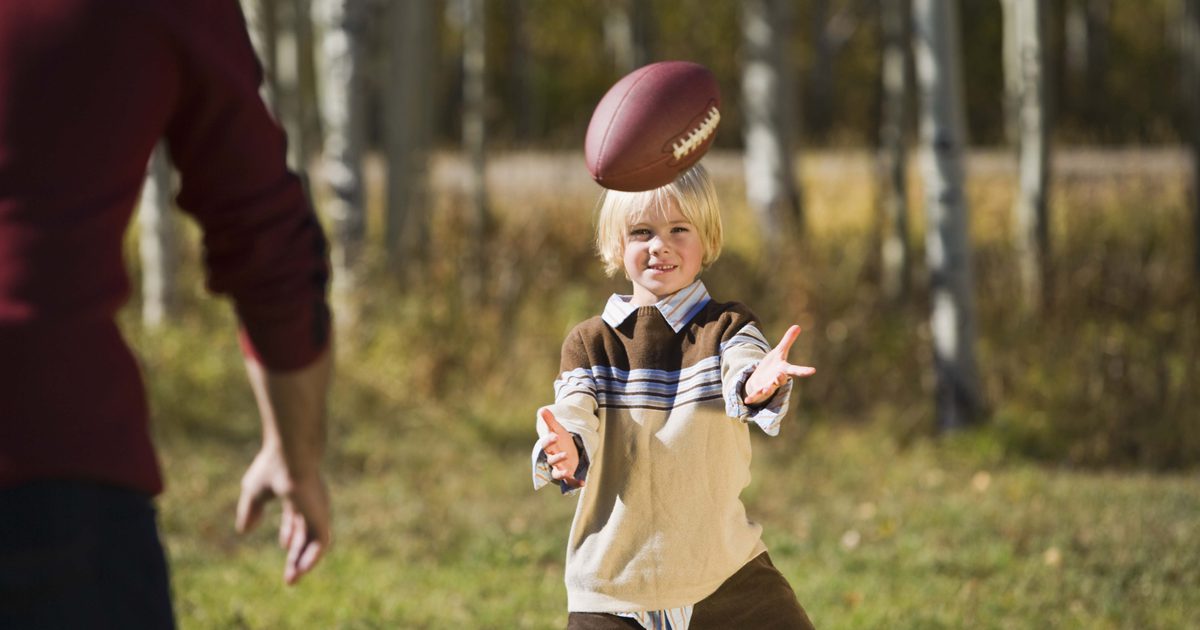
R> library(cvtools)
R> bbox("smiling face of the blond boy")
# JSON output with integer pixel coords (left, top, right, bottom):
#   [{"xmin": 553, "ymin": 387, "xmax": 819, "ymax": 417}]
[{"xmin": 623, "ymin": 196, "xmax": 704, "ymax": 306}]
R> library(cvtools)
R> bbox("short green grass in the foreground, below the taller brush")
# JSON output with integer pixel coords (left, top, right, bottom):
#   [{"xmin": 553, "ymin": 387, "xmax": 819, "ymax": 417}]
[{"xmin": 150, "ymin": 376, "xmax": 1200, "ymax": 629}]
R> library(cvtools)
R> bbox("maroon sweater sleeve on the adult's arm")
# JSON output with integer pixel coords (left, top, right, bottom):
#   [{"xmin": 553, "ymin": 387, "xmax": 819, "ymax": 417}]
[{"xmin": 167, "ymin": 0, "xmax": 330, "ymax": 370}]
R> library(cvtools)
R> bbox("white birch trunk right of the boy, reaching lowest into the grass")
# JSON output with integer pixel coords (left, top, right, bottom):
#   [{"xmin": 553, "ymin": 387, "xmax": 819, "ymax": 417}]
[{"xmin": 912, "ymin": 0, "xmax": 982, "ymax": 431}]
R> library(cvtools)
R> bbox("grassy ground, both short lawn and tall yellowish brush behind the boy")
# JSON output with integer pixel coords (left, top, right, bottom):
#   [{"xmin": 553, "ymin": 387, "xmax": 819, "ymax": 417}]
[{"xmin": 126, "ymin": 147, "xmax": 1200, "ymax": 629}]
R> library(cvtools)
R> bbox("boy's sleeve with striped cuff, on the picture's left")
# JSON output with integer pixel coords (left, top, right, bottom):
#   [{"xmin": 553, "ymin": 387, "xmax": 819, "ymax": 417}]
[{"xmin": 532, "ymin": 330, "xmax": 600, "ymax": 494}]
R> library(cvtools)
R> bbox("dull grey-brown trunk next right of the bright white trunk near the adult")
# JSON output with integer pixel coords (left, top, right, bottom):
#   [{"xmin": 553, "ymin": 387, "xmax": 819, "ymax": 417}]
[{"xmin": 384, "ymin": 0, "xmax": 437, "ymax": 269}]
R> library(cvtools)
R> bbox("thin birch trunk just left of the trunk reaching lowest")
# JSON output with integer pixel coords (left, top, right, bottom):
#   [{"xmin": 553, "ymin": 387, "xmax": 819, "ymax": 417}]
[{"xmin": 880, "ymin": 0, "xmax": 912, "ymax": 300}]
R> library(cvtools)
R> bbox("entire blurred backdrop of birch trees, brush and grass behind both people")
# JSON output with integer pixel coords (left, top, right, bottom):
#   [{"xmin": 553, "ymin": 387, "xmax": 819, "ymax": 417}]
[{"xmin": 124, "ymin": 0, "xmax": 1200, "ymax": 628}]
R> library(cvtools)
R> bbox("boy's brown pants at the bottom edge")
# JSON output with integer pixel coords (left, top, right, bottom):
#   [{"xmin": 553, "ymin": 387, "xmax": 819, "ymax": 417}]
[{"xmin": 566, "ymin": 552, "xmax": 812, "ymax": 630}]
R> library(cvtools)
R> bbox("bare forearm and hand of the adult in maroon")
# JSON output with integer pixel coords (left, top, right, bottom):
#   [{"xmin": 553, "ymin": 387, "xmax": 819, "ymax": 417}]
[{"xmin": 236, "ymin": 347, "xmax": 332, "ymax": 584}]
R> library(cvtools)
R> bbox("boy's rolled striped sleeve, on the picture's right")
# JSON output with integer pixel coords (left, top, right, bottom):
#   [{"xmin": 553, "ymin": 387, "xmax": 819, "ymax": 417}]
[{"xmin": 721, "ymin": 322, "xmax": 792, "ymax": 436}]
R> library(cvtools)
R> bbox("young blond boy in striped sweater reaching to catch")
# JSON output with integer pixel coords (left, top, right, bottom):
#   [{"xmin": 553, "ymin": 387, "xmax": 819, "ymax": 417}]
[{"xmin": 533, "ymin": 164, "xmax": 814, "ymax": 630}]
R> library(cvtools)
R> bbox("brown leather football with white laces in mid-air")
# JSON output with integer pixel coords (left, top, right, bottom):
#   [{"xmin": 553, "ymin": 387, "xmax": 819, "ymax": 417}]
[{"xmin": 583, "ymin": 61, "xmax": 721, "ymax": 192}]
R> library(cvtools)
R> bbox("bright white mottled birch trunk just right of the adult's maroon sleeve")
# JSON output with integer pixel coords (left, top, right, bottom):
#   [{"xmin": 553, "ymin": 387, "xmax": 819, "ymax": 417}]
[{"xmin": 318, "ymin": 0, "xmax": 367, "ymax": 302}]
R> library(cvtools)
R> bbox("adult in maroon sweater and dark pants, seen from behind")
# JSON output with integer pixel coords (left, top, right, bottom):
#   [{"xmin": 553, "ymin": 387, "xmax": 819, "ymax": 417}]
[{"xmin": 0, "ymin": 0, "xmax": 330, "ymax": 628}]
